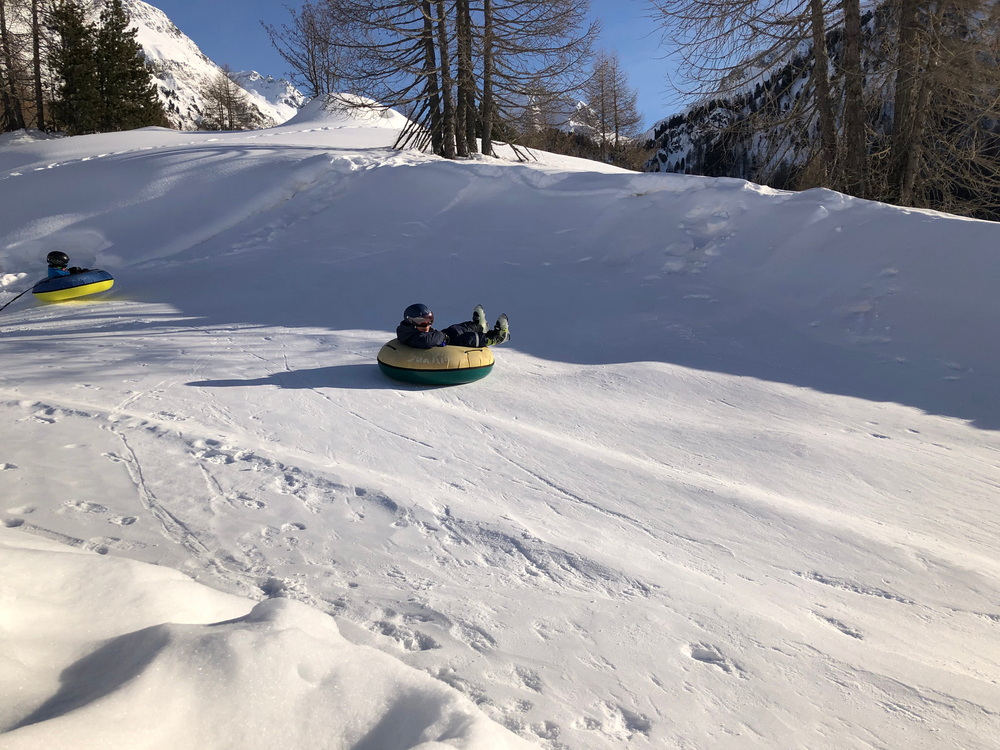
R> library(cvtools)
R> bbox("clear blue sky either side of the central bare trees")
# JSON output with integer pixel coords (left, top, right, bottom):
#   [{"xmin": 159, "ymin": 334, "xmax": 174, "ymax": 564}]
[{"xmin": 147, "ymin": 0, "xmax": 682, "ymax": 127}]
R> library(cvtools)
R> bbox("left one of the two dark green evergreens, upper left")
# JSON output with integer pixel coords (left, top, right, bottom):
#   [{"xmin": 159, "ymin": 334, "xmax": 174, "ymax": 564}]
[{"xmin": 50, "ymin": 0, "xmax": 103, "ymax": 135}]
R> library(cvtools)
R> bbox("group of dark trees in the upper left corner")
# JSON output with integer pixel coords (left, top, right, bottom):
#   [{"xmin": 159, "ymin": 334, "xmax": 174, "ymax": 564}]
[{"xmin": 0, "ymin": 0, "xmax": 169, "ymax": 135}]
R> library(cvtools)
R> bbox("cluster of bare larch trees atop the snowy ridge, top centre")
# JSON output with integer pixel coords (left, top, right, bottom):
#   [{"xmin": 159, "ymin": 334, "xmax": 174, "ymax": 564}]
[{"xmin": 266, "ymin": 0, "xmax": 599, "ymax": 158}]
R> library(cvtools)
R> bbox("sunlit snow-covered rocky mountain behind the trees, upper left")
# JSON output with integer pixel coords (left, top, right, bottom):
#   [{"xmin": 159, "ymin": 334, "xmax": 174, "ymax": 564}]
[{"xmin": 90, "ymin": 0, "xmax": 305, "ymax": 130}]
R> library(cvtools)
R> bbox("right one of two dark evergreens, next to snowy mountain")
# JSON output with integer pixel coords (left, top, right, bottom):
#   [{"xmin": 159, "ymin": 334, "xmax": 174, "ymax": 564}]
[{"xmin": 96, "ymin": 0, "xmax": 168, "ymax": 132}]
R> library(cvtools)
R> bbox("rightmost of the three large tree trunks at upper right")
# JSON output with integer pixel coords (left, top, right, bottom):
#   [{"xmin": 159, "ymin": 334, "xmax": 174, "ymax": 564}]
[{"xmin": 889, "ymin": 0, "xmax": 922, "ymax": 206}]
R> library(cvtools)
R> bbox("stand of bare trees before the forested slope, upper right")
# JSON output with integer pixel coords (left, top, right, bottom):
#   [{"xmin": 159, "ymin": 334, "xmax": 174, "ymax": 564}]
[{"xmin": 650, "ymin": 0, "xmax": 1000, "ymax": 218}]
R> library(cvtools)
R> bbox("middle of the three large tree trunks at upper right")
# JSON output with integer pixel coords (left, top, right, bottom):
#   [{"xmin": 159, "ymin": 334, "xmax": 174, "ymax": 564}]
[{"xmin": 843, "ymin": 0, "xmax": 868, "ymax": 196}]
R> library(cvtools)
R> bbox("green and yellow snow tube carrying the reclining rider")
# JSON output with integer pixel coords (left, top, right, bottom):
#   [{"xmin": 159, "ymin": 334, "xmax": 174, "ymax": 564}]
[{"xmin": 378, "ymin": 339, "xmax": 494, "ymax": 385}]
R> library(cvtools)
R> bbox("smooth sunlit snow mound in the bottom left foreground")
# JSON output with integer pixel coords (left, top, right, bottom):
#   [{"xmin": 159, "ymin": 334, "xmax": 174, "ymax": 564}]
[{"xmin": 0, "ymin": 532, "xmax": 530, "ymax": 750}]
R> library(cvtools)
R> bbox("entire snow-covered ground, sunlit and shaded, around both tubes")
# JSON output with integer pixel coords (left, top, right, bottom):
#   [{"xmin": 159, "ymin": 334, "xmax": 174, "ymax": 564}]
[{"xmin": 0, "ymin": 101, "xmax": 1000, "ymax": 750}]
